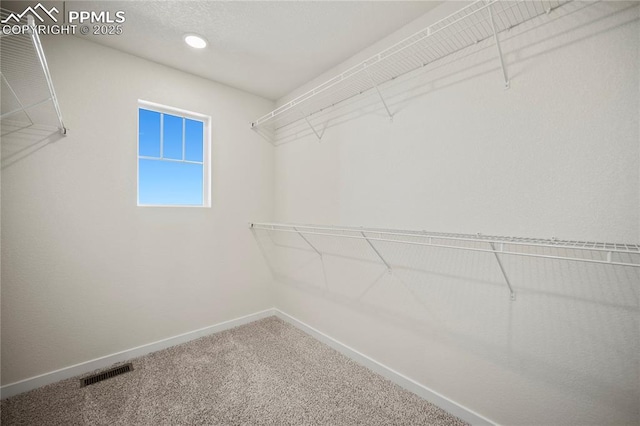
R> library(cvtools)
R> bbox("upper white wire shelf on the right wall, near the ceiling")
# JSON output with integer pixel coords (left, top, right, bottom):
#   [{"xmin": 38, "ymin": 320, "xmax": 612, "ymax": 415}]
[{"xmin": 251, "ymin": 0, "xmax": 570, "ymax": 140}]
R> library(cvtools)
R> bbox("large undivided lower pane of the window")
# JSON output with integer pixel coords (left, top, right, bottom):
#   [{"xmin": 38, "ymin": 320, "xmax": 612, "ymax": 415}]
[{"xmin": 138, "ymin": 158, "xmax": 203, "ymax": 206}]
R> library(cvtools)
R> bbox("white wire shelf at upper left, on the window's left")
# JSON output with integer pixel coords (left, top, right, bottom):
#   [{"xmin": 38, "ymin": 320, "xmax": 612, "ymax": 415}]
[{"xmin": 0, "ymin": 9, "xmax": 67, "ymax": 135}]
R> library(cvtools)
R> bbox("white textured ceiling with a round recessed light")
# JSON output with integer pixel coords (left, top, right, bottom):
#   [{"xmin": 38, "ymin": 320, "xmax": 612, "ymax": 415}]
[{"xmin": 66, "ymin": 1, "xmax": 440, "ymax": 100}]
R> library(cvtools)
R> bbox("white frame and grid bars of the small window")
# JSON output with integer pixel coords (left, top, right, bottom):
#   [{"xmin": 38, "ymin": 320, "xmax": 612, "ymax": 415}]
[{"xmin": 136, "ymin": 99, "xmax": 211, "ymax": 208}]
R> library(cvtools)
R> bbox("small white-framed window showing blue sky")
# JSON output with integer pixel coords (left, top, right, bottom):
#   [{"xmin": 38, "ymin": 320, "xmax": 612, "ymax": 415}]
[{"xmin": 138, "ymin": 101, "xmax": 211, "ymax": 207}]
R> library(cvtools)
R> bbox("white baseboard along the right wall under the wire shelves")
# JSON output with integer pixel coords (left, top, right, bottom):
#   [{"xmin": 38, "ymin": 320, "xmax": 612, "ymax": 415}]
[{"xmin": 273, "ymin": 308, "xmax": 496, "ymax": 425}]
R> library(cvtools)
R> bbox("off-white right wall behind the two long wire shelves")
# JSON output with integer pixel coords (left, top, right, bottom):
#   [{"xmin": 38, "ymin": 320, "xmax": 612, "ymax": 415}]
[{"xmin": 268, "ymin": 2, "xmax": 640, "ymax": 424}]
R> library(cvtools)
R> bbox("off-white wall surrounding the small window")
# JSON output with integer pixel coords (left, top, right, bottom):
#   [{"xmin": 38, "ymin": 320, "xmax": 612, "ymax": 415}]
[{"xmin": 2, "ymin": 36, "xmax": 273, "ymax": 384}]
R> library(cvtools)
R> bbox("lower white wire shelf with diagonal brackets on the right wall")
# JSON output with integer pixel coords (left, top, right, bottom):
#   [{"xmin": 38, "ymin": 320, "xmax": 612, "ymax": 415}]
[{"xmin": 249, "ymin": 223, "xmax": 640, "ymax": 300}]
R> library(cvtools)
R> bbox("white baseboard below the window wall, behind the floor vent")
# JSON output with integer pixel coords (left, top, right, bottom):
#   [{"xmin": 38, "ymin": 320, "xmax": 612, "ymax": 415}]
[{"xmin": 0, "ymin": 309, "xmax": 275, "ymax": 399}]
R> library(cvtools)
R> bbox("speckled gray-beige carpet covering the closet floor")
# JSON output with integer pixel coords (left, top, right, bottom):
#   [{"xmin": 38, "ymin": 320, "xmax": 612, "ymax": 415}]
[{"xmin": 1, "ymin": 317, "xmax": 465, "ymax": 426}]
